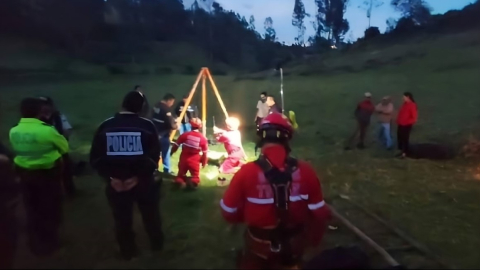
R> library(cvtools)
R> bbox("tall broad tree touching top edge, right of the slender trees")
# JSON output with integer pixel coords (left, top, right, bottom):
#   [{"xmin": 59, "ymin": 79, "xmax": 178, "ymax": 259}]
[{"xmin": 315, "ymin": 0, "xmax": 350, "ymax": 43}]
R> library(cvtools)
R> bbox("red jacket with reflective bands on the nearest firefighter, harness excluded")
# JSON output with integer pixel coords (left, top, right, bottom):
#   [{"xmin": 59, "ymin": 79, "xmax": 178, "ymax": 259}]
[{"xmin": 220, "ymin": 145, "xmax": 330, "ymax": 230}]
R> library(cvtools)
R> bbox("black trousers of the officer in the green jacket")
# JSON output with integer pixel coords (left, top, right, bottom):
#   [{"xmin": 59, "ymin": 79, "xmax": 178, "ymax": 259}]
[{"xmin": 17, "ymin": 162, "xmax": 63, "ymax": 256}]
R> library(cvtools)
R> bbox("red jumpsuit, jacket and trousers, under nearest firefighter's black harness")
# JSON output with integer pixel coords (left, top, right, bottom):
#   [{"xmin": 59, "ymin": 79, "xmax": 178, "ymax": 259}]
[{"xmin": 220, "ymin": 145, "xmax": 330, "ymax": 269}]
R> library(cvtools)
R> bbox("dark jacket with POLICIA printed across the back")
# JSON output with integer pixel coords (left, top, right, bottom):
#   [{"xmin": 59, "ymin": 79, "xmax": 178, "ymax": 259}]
[{"xmin": 90, "ymin": 113, "xmax": 160, "ymax": 180}]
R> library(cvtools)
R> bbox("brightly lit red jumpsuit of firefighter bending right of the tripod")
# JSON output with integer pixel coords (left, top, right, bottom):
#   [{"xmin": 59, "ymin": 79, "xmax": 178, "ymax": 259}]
[{"xmin": 215, "ymin": 130, "xmax": 245, "ymax": 174}]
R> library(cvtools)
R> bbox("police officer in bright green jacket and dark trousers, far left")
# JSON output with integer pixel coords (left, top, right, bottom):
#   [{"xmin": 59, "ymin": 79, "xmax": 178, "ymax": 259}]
[{"xmin": 10, "ymin": 98, "xmax": 68, "ymax": 255}]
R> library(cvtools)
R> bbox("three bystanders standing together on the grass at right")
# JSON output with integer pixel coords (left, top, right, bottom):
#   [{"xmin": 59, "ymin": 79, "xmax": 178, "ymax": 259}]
[{"xmin": 345, "ymin": 92, "xmax": 418, "ymax": 158}]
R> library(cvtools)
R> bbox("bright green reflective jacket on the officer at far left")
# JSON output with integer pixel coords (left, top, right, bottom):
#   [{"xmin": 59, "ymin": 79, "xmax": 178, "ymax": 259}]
[{"xmin": 10, "ymin": 118, "xmax": 68, "ymax": 170}]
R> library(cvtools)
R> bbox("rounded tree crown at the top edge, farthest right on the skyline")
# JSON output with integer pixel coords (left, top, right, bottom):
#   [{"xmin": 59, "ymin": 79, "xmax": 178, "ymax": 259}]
[{"xmin": 391, "ymin": 0, "xmax": 432, "ymax": 25}]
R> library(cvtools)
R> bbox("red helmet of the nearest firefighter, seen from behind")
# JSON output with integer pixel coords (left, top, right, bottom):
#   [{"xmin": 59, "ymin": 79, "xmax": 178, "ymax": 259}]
[{"xmin": 258, "ymin": 113, "xmax": 293, "ymax": 140}]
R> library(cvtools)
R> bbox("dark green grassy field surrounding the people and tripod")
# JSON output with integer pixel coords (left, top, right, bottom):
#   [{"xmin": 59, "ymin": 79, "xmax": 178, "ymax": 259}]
[{"xmin": 0, "ymin": 29, "xmax": 480, "ymax": 269}]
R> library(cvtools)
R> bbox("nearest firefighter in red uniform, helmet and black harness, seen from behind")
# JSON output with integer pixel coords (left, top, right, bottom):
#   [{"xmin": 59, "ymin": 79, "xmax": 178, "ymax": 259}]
[{"xmin": 220, "ymin": 113, "xmax": 330, "ymax": 269}]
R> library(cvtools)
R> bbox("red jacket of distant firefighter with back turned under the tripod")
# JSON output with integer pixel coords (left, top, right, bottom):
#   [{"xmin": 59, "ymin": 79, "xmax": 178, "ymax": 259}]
[{"xmin": 172, "ymin": 130, "xmax": 208, "ymax": 166}]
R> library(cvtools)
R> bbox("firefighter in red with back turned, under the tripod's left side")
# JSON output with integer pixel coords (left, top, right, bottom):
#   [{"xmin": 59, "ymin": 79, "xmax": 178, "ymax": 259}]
[{"xmin": 171, "ymin": 118, "xmax": 208, "ymax": 188}]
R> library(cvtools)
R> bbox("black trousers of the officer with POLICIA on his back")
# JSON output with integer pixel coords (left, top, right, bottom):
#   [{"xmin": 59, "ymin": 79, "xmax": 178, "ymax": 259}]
[{"xmin": 106, "ymin": 178, "xmax": 163, "ymax": 256}]
